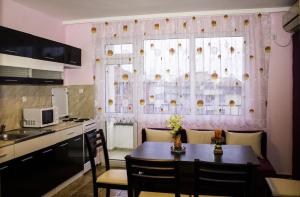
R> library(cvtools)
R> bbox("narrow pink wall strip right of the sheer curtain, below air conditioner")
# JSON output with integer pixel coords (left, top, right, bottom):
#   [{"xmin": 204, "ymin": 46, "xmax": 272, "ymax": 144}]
[{"xmin": 267, "ymin": 13, "xmax": 293, "ymax": 174}]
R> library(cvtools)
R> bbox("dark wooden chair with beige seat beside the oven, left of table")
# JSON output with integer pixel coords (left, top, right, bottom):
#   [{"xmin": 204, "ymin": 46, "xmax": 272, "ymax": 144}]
[{"xmin": 84, "ymin": 129, "xmax": 127, "ymax": 197}]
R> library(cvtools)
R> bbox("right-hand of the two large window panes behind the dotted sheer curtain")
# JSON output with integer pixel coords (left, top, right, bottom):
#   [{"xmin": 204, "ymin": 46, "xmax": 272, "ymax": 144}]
[{"xmin": 195, "ymin": 37, "xmax": 244, "ymax": 115}]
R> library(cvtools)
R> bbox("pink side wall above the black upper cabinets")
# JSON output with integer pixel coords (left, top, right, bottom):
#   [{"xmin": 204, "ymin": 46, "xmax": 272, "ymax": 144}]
[{"xmin": 0, "ymin": 0, "xmax": 65, "ymax": 42}]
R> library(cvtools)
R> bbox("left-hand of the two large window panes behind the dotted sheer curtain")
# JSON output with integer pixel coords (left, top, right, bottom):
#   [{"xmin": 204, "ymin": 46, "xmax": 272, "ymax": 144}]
[{"xmin": 144, "ymin": 39, "xmax": 190, "ymax": 113}]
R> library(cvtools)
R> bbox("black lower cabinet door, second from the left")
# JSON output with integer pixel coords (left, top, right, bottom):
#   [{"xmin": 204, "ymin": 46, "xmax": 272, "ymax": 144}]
[{"xmin": 14, "ymin": 152, "xmax": 40, "ymax": 197}]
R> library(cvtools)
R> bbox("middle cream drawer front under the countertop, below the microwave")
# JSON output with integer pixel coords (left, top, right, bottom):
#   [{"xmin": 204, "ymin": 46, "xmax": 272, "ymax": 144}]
[{"xmin": 15, "ymin": 133, "xmax": 56, "ymax": 157}]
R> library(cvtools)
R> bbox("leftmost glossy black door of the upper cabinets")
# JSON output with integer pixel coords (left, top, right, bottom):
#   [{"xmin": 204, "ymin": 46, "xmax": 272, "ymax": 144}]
[{"xmin": 0, "ymin": 26, "xmax": 34, "ymax": 57}]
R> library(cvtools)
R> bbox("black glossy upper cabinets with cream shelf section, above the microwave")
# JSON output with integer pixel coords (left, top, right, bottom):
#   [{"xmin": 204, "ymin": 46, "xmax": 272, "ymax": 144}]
[{"xmin": 0, "ymin": 26, "xmax": 81, "ymax": 84}]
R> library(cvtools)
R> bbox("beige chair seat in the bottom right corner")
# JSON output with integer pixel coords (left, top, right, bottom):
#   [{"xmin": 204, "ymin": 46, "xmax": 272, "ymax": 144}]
[{"xmin": 266, "ymin": 178, "xmax": 300, "ymax": 196}]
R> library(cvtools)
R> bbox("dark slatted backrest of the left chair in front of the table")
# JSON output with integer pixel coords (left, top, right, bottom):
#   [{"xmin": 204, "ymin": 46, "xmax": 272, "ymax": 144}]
[{"xmin": 125, "ymin": 155, "xmax": 180, "ymax": 197}]
